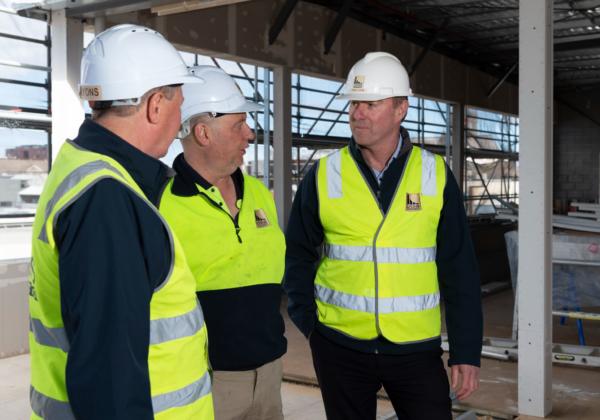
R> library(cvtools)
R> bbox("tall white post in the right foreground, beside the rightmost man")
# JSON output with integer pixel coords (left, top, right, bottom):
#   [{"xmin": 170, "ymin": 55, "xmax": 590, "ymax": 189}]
[{"xmin": 517, "ymin": 0, "xmax": 553, "ymax": 417}]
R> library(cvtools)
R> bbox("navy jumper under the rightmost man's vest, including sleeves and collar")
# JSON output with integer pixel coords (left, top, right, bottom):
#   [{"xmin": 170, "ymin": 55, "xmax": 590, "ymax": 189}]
[{"xmin": 284, "ymin": 127, "xmax": 483, "ymax": 366}]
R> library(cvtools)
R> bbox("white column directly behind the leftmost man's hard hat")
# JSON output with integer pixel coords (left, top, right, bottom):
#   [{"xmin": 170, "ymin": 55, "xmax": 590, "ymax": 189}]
[{"xmin": 51, "ymin": 9, "xmax": 84, "ymax": 161}]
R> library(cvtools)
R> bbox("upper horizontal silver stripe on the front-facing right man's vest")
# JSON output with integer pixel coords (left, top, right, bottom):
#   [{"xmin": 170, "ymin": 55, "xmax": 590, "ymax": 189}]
[{"xmin": 325, "ymin": 244, "xmax": 436, "ymax": 264}]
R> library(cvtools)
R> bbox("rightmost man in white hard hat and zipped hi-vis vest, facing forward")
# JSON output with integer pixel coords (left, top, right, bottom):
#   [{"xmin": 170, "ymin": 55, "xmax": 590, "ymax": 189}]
[{"xmin": 284, "ymin": 52, "xmax": 482, "ymax": 420}]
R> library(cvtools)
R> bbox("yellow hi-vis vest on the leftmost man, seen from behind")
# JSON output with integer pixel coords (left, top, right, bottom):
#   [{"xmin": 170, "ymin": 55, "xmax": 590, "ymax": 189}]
[{"xmin": 29, "ymin": 141, "xmax": 213, "ymax": 420}]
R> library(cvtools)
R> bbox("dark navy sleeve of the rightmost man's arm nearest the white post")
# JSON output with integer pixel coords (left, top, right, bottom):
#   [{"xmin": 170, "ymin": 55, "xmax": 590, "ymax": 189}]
[{"xmin": 436, "ymin": 169, "xmax": 483, "ymax": 366}]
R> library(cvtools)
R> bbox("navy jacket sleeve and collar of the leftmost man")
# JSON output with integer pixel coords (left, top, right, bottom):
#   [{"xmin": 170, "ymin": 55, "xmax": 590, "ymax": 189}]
[{"xmin": 55, "ymin": 120, "xmax": 172, "ymax": 420}]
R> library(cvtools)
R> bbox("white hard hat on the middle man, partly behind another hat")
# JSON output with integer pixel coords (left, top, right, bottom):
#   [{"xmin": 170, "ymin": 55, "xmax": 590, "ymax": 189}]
[{"xmin": 180, "ymin": 66, "xmax": 263, "ymax": 137}]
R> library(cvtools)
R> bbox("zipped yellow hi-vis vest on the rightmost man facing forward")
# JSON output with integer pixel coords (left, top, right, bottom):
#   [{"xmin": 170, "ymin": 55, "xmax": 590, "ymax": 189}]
[{"xmin": 315, "ymin": 147, "xmax": 446, "ymax": 344}]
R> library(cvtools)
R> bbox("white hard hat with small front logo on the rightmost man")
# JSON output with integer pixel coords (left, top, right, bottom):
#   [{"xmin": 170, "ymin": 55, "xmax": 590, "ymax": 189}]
[{"xmin": 336, "ymin": 52, "xmax": 412, "ymax": 101}]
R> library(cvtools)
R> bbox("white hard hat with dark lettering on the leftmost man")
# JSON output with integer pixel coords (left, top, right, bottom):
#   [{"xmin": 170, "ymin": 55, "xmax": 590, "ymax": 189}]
[{"xmin": 79, "ymin": 24, "xmax": 204, "ymax": 105}]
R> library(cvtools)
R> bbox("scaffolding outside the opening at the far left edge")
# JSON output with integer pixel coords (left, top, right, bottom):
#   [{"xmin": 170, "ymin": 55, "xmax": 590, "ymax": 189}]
[{"xmin": 0, "ymin": 8, "xmax": 52, "ymax": 217}]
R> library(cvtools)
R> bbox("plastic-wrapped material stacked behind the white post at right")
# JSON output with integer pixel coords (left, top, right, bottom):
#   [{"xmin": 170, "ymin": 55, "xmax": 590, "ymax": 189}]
[{"xmin": 504, "ymin": 231, "xmax": 600, "ymax": 310}]
